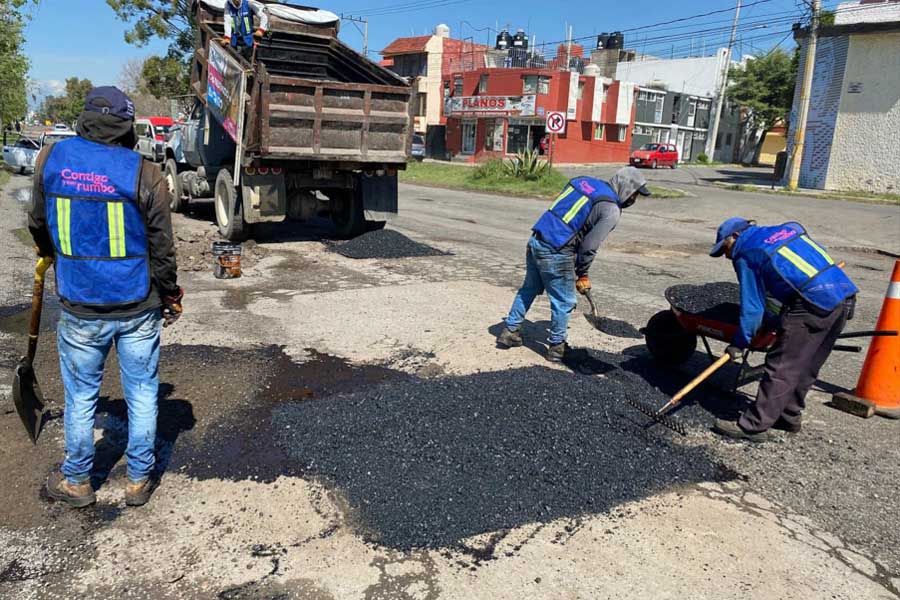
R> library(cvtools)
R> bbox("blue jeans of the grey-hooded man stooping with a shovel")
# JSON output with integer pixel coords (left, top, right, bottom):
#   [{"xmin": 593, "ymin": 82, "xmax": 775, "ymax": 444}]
[{"xmin": 506, "ymin": 236, "xmax": 578, "ymax": 345}]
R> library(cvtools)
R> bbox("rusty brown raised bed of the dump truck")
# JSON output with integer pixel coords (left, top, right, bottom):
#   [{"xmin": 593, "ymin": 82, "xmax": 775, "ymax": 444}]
[{"xmin": 192, "ymin": 2, "xmax": 413, "ymax": 168}]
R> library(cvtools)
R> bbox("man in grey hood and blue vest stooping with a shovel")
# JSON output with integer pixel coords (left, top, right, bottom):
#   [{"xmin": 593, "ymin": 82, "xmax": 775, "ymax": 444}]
[{"xmin": 497, "ymin": 167, "xmax": 650, "ymax": 362}]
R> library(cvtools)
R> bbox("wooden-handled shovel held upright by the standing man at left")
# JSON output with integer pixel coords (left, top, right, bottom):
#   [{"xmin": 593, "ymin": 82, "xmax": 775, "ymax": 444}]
[{"xmin": 13, "ymin": 256, "xmax": 53, "ymax": 444}]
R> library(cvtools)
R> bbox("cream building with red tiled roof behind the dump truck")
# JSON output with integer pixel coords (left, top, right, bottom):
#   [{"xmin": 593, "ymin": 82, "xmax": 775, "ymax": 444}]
[{"xmin": 380, "ymin": 25, "xmax": 486, "ymax": 133}]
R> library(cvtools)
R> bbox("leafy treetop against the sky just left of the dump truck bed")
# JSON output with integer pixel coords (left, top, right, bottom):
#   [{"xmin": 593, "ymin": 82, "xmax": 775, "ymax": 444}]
[{"xmin": 106, "ymin": 0, "xmax": 196, "ymax": 62}]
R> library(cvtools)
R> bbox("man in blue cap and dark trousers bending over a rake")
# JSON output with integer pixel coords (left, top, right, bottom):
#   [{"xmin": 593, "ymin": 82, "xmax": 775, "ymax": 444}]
[{"xmin": 709, "ymin": 217, "xmax": 858, "ymax": 442}]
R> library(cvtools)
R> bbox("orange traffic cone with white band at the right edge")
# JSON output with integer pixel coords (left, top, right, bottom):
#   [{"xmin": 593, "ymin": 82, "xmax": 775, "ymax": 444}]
[{"xmin": 832, "ymin": 260, "xmax": 900, "ymax": 419}]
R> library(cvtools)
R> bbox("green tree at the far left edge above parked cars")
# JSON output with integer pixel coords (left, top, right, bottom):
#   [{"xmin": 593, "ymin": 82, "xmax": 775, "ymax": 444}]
[{"xmin": 0, "ymin": 0, "xmax": 35, "ymax": 130}]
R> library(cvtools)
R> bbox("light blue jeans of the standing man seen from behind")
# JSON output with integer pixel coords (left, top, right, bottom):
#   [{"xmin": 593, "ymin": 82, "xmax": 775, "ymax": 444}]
[{"xmin": 57, "ymin": 310, "xmax": 162, "ymax": 484}]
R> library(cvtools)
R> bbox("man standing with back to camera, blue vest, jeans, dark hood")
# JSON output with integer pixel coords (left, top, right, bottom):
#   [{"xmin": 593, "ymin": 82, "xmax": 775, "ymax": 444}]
[{"xmin": 28, "ymin": 87, "xmax": 183, "ymax": 508}]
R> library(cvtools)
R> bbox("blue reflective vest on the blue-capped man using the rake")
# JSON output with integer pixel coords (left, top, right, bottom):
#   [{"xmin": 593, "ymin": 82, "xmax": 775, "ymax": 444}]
[{"xmin": 733, "ymin": 223, "xmax": 859, "ymax": 311}]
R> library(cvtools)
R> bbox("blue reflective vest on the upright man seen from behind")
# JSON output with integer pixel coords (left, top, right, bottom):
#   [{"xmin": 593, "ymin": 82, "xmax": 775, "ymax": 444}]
[{"xmin": 43, "ymin": 136, "xmax": 150, "ymax": 306}]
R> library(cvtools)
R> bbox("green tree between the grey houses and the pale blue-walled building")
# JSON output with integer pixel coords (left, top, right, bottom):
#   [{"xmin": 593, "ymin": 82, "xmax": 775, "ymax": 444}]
[{"xmin": 727, "ymin": 49, "xmax": 797, "ymax": 163}]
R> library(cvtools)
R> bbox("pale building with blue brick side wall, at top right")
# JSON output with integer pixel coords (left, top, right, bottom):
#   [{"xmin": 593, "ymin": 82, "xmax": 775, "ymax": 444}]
[{"xmin": 788, "ymin": 0, "xmax": 900, "ymax": 193}]
